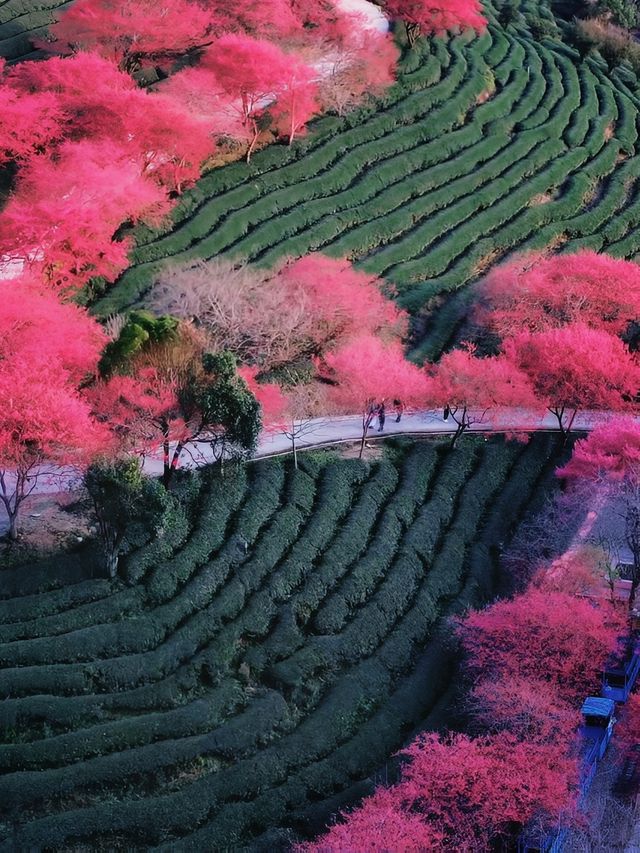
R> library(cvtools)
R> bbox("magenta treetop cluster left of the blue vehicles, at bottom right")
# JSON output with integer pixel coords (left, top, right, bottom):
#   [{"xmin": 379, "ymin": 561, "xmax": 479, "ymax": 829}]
[{"xmin": 298, "ymin": 548, "xmax": 620, "ymax": 853}]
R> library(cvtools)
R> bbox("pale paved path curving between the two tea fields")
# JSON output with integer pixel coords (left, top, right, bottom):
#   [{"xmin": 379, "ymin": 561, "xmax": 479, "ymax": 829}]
[{"xmin": 0, "ymin": 410, "xmax": 616, "ymax": 535}]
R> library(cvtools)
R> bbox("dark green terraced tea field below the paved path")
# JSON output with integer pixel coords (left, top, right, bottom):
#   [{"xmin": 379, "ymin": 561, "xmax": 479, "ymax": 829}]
[{"xmin": 0, "ymin": 435, "xmax": 556, "ymax": 850}]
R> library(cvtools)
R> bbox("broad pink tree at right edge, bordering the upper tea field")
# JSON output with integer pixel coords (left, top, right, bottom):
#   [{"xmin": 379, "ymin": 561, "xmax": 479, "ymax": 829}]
[{"xmin": 477, "ymin": 250, "xmax": 640, "ymax": 338}]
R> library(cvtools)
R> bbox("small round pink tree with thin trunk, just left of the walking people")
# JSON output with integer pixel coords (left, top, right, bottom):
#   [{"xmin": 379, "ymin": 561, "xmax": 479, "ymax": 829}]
[{"xmin": 319, "ymin": 334, "xmax": 426, "ymax": 456}]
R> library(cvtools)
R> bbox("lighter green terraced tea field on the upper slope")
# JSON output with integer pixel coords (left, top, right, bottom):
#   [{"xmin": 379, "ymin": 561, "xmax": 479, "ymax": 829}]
[{"xmin": 79, "ymin": 3, "xmax": 640, "ymax": 355}]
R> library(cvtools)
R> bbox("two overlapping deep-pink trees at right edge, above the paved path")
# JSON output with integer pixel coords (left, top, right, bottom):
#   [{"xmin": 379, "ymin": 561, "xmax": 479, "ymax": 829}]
[{"xmin": 470, "ymin": 252, "xmax": 640, "ymax": 433}]
